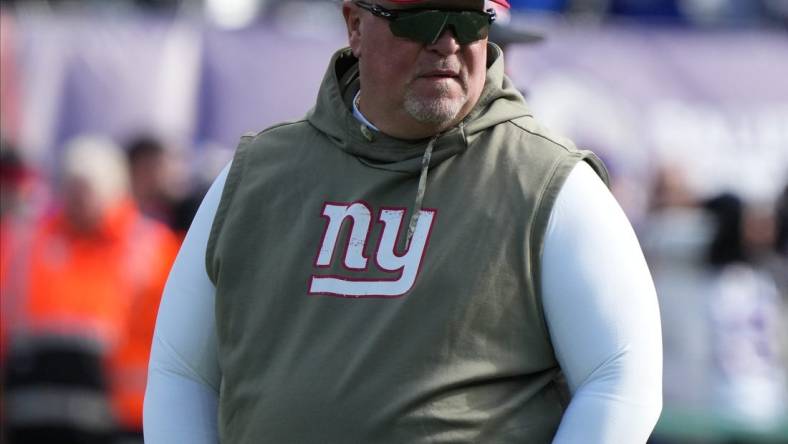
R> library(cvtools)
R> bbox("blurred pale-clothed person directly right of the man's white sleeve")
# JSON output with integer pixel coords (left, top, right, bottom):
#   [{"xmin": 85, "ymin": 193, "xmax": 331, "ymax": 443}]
[{"xmin": 639, "ymin": 164, "xmax": 712, "ymax": 416}]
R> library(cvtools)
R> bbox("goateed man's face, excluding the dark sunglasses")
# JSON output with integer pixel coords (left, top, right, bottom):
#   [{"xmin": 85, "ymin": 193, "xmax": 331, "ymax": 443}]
[{"xmin": 344, "ymin": 0, "xmax": 487, "ymax": 138}]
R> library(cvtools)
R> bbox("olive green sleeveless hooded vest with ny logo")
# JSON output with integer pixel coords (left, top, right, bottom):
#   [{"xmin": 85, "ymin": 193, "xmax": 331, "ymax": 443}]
[{"xmin": 206, "ymin": 44, "xmax": 607, "ymax": 444}]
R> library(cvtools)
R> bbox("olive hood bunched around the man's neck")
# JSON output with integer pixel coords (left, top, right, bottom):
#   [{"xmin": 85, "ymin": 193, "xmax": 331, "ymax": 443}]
[{"xmin": 307, "ymin": 43, "xmax": 530, "ymax": 174}]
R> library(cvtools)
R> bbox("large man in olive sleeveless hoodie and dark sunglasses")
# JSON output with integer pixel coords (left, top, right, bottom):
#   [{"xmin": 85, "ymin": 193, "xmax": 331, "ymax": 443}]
[{"xmin": 145, "ymin": 0, "xmax": 661, "ymax": 444}]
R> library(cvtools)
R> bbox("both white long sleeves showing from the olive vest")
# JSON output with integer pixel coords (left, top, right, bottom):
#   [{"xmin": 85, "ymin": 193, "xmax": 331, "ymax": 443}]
[{"xmin": 144, "ymin": 162, "xmax": 662, "ymax": 444}]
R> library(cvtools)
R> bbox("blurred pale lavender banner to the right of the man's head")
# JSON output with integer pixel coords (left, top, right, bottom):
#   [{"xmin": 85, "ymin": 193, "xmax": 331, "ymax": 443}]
[{"xmin": 510, "ymin": 25, "xmax": 788, "ymax": 200}]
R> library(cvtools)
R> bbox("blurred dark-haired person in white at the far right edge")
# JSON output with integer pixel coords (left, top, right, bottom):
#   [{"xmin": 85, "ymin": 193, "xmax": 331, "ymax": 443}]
[{"xmin": 704, "ymin": 193, "xmax": 788, "ymax": 430}]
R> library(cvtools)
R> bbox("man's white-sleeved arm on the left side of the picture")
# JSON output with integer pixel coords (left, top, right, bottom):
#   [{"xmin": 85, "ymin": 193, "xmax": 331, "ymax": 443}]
[{"xmin": 144, "ymin": 165, "xmax": 229, "ymax": 444}]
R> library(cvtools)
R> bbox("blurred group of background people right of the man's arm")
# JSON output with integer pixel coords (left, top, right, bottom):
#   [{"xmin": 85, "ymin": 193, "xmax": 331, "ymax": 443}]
[{"xmin": 638, "ymin": 165, "xmax": 788, "ymax": 443}]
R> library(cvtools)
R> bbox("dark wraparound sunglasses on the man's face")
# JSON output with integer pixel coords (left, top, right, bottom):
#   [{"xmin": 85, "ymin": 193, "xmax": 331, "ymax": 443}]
[{"xmin": 354, "ymin": 2, "xmax": 495, "ymax": 45}]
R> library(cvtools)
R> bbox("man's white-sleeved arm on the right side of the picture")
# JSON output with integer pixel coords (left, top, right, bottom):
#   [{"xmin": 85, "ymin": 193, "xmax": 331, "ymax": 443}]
[{"xmin": 542, "ymin": 162, "xmax": 662, "ymax": 444}]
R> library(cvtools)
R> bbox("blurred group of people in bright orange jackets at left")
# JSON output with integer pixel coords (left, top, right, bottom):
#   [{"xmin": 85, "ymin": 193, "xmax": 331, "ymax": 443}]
[{"xmin": 0, "ymin": 135, "xmax": 219, "ymax": 444}]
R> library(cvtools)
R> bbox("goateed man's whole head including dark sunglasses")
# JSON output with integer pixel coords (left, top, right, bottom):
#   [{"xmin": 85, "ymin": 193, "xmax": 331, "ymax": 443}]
[{"xmin": 343, "ymin": 0, "xmax": 505, "ymax": 139}]
